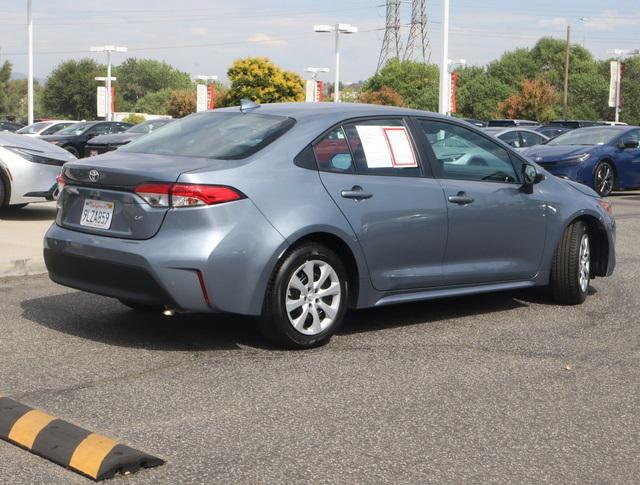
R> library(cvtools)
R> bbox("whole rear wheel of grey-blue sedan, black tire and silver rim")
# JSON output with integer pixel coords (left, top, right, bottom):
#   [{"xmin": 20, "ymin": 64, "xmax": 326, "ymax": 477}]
[{"xmin": 259, "ymin": 243, "xmax": 348, "ymax": 349}]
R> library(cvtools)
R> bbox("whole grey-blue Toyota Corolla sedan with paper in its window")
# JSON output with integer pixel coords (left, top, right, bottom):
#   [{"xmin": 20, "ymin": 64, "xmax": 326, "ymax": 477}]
[{"xmin": 44, "ymin": 103, "xmax": 615, "ymax": 348}]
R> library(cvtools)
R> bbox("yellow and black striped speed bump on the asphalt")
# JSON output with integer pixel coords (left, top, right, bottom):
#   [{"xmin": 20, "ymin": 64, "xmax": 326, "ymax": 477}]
[{"xmin": 0, "ymin": 396, "xmax": 164, "ymax": 481}]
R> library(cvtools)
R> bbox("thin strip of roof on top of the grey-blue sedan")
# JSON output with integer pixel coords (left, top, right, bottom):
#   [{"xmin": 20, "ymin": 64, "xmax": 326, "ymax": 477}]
[{"xmin": 215, "ymin": 103, "xmax": 449, "ymax": 119}]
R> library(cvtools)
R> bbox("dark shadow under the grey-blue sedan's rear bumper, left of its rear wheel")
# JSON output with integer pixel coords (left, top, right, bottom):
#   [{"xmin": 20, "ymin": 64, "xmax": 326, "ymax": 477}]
[{"xmin": 21, "ymin": 292, "xmax": 268, "ymax": 351}]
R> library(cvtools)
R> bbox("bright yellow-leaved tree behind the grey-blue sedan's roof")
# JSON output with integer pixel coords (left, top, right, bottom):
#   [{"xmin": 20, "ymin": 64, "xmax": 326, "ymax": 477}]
[{"xmin": 226, "ymin": 57, "xmax": 304, "ymax": 105}]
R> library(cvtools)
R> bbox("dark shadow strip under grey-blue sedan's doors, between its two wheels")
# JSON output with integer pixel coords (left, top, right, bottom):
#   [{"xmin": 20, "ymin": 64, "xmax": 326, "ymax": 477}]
[{"xmin": 338, "ymin": 292, "xmax": 528, "ymax": 335}]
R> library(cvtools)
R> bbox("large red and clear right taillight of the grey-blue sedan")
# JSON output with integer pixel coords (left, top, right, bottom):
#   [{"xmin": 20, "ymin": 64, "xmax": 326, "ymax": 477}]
[{"xmin": 135, "ymin": 182, "xmax": 243, "ymax": 207}]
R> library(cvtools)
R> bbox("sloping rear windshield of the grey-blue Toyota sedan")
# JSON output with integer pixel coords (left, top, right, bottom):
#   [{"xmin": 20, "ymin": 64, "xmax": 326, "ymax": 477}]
[{"xmin": 119, "ymin": 111, "xmax": 295, "ymax": 160}]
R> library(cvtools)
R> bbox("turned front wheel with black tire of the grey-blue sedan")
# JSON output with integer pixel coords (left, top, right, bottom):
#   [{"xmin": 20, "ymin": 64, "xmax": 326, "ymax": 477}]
[{"xmin": 550, "ymin": 221, "xmax": 591, "ymax": 305}]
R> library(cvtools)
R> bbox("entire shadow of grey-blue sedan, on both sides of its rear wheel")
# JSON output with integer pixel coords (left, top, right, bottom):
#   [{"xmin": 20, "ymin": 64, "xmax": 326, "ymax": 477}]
[{"xmin": 21, "ymin": 292, "xmax": 527, "ymax": 351}]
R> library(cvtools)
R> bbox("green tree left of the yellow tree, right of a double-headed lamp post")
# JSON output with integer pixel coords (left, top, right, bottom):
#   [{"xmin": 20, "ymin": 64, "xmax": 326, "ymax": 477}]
[{"xmin": 114, "ymin": 57, "xmax": 193, "ymax": 111}]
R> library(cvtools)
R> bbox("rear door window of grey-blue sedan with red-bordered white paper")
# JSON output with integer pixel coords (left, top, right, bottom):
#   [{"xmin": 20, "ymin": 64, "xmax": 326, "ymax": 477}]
[{"xmin": 344, "ymin": 118, "xmax": 422, "ymax": 177}]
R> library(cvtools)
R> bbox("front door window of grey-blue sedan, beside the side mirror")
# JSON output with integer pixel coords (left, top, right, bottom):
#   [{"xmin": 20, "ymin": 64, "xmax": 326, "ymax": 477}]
[{"xmin": 419, "ymin": 119, "xmax": 518, "ymax": 183}]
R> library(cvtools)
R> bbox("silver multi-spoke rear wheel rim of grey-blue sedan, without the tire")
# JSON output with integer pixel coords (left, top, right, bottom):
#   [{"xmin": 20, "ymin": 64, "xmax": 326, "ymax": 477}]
[{"xmin": 285, "ymin": 259, "xmax": 342, "ymax": 335}]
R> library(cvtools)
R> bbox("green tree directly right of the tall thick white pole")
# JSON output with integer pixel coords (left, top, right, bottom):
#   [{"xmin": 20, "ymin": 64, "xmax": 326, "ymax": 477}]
[{"xmin": 457, "ymin": 66, "xmax": 515, "ymax": 120}]
